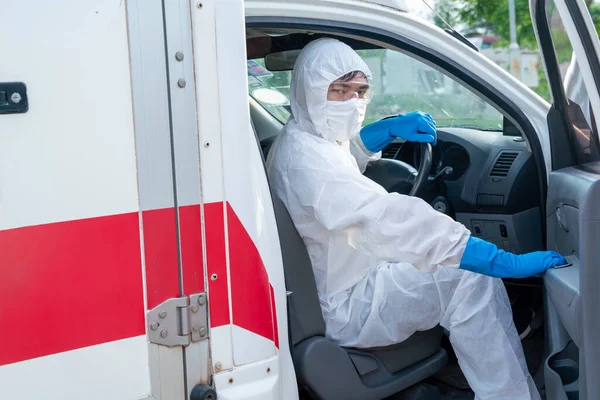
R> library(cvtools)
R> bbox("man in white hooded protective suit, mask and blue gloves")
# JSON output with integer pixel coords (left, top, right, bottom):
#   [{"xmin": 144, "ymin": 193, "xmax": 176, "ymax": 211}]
[{"xmin": 267, "ymin": 38, "xmax": 566, "ymax": 399}]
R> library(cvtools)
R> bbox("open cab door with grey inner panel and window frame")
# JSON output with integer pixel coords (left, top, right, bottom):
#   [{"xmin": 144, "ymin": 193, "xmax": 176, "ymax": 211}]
[{"xmin": 530, "ymin": 0, "xmax": 600, "ymax": 399}]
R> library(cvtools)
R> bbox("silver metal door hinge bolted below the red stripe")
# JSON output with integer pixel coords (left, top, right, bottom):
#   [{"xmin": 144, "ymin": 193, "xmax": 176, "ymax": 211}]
[{"xmin": 147, "ymin": 293, "xmax": 208, "ymax": 347}]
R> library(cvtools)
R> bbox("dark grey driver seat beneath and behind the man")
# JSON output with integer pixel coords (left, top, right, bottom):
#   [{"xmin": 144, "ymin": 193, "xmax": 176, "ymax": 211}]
[{"xmin": 253, "ymin": 126, "xmax": 448, "ymax": 400}]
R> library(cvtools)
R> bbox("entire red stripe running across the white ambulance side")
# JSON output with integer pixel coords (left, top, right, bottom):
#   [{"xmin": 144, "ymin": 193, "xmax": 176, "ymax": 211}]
[{"xmin": 0, "ymin": 202, "xmax": 279, "ymax": 365}]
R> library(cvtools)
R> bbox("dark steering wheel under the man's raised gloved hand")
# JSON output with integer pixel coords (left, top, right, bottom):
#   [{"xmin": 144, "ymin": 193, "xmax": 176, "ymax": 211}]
[{"xmin": 364, "ymin": 143, "xmax": 433, "ymax": 196}]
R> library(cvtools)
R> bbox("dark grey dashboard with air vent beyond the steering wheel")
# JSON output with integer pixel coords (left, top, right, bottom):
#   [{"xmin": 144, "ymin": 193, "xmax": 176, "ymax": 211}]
[{"xmin": 382, "ymin": 127, "xmax": 542, "ymax": 253}]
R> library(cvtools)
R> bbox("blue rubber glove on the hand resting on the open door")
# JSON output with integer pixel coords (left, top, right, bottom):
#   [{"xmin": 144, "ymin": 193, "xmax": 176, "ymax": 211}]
[{"xmin": 460, "ymin": 236, "xmax": 567, "ymax": 278}]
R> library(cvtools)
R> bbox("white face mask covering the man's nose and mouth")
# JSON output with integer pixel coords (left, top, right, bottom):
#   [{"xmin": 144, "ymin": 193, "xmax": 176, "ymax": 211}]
[{"xmin": 323, "ymin": 98, "xmax": 367, "ymax": 142}]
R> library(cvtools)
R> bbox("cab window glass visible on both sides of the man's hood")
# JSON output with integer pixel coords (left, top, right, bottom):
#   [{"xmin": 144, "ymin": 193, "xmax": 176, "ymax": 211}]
[{"xmin": 248, "ymin": 49, "xmax": 503, "ymax": 131}]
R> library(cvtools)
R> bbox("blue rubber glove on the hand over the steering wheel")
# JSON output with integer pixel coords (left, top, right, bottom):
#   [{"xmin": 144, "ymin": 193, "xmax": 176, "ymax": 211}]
[{"xmin": 360, "ymin": 111, "xmax": 437, "ymax": 153}]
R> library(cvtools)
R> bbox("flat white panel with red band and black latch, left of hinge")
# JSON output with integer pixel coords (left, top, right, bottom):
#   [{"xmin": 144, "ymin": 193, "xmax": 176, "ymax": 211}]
[{"xmin": 0, "ymin": 0, "xmax": 150, "ymax": 400}]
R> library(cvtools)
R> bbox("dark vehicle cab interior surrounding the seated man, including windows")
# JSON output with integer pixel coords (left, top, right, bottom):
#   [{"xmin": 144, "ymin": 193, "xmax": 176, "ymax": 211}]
[{"xmin": 247, "ymin": 27, "xmax": 556, "ymax": 399}]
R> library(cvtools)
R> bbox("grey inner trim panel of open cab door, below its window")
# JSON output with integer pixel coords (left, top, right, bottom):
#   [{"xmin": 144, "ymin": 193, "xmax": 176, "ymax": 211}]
[{"xmin": 544, "ymin": 162, "xmax": 600, "ymax": 400}]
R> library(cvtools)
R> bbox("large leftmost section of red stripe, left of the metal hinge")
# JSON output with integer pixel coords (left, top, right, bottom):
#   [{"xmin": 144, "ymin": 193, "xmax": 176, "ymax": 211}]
[{"xmin": 0, "ymin": 213, "xmax": 145, "ymax": 365}]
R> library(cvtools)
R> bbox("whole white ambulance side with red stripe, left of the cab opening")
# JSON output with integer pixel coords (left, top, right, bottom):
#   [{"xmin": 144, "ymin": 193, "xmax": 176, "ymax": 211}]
[{"xmin": 0, "ymin": 0, "xmax": 297, "ymax": 399}]
